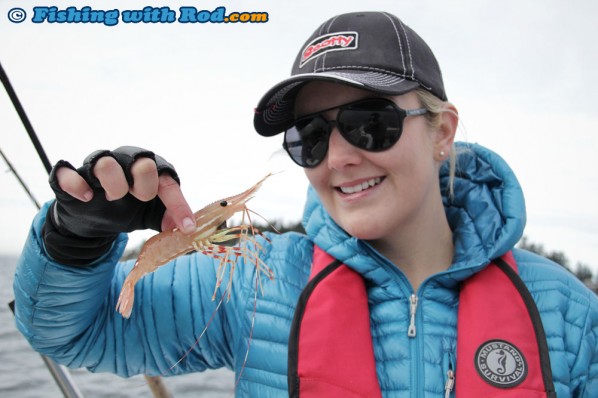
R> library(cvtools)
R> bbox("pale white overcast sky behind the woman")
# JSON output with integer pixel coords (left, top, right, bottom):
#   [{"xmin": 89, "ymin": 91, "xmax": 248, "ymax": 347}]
[{"xmin": 0, "ymin": 0, "xmax": 598, "ymax": 271}]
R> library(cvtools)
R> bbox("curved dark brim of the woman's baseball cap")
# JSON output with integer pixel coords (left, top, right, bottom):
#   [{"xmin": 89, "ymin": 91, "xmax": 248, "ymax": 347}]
[{"xmin": 253, "ymin": 70, "xmax": 419, "ymax": 137}]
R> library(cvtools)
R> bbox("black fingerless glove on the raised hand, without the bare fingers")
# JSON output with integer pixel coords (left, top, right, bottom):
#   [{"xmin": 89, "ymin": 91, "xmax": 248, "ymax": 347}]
[{"xmin": 43, "ymin": 146, "xmax": 180, "ymax": 265}]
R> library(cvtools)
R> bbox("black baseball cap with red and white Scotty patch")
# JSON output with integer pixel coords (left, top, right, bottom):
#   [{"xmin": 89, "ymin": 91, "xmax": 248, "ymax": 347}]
[{"xmin": 253, "ymin": 12, "xmax": 447, "ymax": 137}]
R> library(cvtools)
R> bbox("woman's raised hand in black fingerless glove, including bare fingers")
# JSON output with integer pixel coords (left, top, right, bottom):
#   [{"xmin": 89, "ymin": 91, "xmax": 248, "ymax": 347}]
[{"xmin": 44, "ymin": 147, "xmax": 195, "ymax": 262}]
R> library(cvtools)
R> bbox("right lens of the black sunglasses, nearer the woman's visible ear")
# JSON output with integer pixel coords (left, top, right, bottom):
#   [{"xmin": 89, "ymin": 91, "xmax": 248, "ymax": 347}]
[{"xmin": 337, "ymin": 100, "xmax": 402, "ymax": 151}]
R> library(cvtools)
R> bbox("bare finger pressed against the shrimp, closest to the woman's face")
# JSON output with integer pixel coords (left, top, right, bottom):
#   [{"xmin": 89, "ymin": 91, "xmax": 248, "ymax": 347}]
[{"xmin": 158, "ymin": 174, "xmax": 195, "ymax": 234}]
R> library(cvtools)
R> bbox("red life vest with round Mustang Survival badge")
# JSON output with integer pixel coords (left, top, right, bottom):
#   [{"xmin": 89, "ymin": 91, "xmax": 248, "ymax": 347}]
[{"xmin": 288, "ymin": 247, "xmax": 556, "ymax": 398}]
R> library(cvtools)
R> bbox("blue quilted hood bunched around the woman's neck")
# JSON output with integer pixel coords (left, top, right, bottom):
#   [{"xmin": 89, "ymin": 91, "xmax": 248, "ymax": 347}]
[{"xmin": 303, "ymin": 143, "xmax": 525, "ymax": 282}]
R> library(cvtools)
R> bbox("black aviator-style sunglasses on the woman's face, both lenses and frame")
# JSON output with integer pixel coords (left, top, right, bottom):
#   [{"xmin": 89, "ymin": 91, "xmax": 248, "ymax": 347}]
[{"xmin": 282, "ymin": 98, "xmax": 428, "ymax": 168}]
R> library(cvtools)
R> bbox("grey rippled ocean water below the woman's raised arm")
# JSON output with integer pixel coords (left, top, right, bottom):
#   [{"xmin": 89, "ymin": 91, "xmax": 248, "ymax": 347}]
[{"xmin": 0, "ymin": 255, "xmax": 234, "ymax": 398}]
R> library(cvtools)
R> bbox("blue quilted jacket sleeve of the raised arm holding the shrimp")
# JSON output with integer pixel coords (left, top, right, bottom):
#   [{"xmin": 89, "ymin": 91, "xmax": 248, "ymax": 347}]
[{"xmin": 14, "ymin": 202, "xmax": 236, "ymax": 377}]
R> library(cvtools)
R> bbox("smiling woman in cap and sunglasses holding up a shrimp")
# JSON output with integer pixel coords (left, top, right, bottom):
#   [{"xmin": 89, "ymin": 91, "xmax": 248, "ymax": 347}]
[{"xmin": 15, "ymin": 12, "xmax": 598, "ymax": 398}]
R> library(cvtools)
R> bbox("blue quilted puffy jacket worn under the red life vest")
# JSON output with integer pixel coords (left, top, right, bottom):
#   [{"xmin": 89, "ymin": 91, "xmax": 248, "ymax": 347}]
[{"xmin": 14, "ymin": 145, "xmax": 598, "ymax": 398}]
